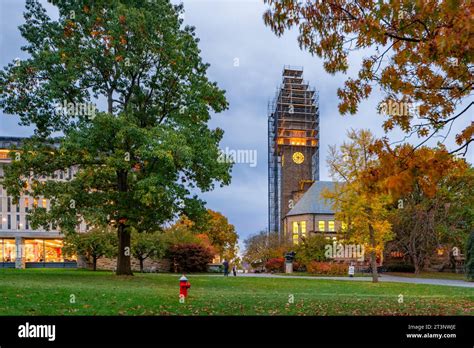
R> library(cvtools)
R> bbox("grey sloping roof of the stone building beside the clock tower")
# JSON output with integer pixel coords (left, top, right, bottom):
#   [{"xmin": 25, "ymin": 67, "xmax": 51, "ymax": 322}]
[{"xmin": 286, "ymin": 181, "xmax": 336, "ymax": 216}]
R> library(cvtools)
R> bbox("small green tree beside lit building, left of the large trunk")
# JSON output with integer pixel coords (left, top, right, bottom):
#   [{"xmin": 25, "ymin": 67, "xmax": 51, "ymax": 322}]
[{"xmin": 63, "ymin": 228, "xmax": 117, "ymax": 271}]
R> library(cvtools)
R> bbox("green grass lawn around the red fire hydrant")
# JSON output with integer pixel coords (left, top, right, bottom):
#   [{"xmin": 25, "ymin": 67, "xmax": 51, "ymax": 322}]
[{"xmin": 0, "ymin": 269, "xmax": 474, "ymax": 315}]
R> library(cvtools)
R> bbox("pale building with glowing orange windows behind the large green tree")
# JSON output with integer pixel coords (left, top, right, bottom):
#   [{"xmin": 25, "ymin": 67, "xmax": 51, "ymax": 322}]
[{"xmin": 0, "ymin": 137, "xmax": 87, "ymax": 268}]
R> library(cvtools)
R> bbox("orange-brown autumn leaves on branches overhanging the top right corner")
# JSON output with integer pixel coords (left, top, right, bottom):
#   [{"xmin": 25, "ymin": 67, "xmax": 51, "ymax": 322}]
[{"xmin": 264, "ymin": 0, "xmax": 474, "ymax": 153}]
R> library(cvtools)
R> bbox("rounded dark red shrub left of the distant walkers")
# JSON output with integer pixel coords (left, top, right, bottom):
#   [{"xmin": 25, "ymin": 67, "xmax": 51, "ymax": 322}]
[{"xmin": 167, "ymin": 243, "xmax": 214, "ymax": 272}]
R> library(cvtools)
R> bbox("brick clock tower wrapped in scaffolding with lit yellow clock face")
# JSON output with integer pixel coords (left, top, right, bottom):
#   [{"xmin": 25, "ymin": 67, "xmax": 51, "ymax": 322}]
[{"xmin": 268, "ymin": 66, "xmax": 319, "ymax": 237}]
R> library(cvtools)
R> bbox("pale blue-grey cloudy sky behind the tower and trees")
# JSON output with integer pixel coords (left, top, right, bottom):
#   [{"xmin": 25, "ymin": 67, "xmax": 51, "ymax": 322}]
[{"xmin": 0, "ymin": 0, "xmax": 473, "ymax": 249}]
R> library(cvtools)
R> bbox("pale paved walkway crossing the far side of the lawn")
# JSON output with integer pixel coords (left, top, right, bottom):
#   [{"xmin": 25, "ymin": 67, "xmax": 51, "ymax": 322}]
[{"xmin": 226, "ymin": 273, "xmax": 474, "ymax": 288}]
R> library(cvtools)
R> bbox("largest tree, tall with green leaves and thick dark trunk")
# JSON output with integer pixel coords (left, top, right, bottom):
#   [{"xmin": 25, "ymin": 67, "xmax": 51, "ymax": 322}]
[{"xmin": 0, "ymin": 0, "xmax": 231, "ymax": 275}]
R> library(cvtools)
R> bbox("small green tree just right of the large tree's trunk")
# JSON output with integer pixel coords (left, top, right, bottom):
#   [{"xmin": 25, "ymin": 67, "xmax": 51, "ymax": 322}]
[{"xmin": 131, "ymin": 229, "xmax": 166, "ymax": 273}]
